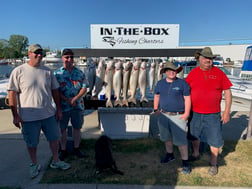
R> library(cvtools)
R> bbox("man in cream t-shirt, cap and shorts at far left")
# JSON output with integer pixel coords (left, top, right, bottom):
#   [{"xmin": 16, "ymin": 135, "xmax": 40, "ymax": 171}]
[{"xmin": 8, "ymin": 44, "xmax": 71, "ymax": 178}]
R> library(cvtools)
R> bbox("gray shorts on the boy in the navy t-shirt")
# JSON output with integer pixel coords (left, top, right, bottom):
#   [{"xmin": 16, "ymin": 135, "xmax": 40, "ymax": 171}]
[{"xmin": 157, "ymin": 112, "xmax": 187, "ymax": 146}]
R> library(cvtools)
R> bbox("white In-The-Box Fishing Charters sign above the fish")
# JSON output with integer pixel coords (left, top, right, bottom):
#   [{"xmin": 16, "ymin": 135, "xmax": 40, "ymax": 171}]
[{"xmin": 91, "ymin": 24, "xmax": 179, "ymax": 49}]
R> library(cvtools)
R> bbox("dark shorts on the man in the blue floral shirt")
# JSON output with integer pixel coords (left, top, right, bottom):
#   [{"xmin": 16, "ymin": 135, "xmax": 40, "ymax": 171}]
[{"xmin": 60, "ymin": 110, "xmax": 84, "ymax": 129}]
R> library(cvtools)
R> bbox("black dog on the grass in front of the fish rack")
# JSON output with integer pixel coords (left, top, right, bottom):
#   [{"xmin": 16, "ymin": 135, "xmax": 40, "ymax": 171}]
[{"xmin": 95, "ymin": 135, "xmax": 123, "ymax": 175}]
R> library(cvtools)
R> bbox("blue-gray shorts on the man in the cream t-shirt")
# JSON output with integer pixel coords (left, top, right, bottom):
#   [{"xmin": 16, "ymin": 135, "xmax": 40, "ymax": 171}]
[{"xmin": 22, "ymin": 116, "xmax": 60, "ymax": 148}]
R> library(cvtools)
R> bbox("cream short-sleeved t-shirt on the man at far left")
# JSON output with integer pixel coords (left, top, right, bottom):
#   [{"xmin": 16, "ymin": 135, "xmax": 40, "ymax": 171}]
[{"xmin": 8, "ymin": 63, "xmax": 59, "ymax": 121}]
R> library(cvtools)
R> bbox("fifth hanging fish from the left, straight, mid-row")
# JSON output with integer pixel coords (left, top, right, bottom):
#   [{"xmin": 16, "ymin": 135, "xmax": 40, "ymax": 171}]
[{"xmin": 122, "ymin": 61, "xmax": 132, "ymax": 106}]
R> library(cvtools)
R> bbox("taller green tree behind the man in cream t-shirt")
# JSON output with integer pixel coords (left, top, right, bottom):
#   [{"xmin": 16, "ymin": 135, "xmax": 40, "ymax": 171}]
[{"xmin": 8, "ymin": 35, "xmax": 29, "ymax": 58}]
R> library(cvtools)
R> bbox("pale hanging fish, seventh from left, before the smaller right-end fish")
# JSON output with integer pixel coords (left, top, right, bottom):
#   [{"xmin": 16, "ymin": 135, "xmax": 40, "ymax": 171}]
[{"xmin": 138, "ymin": 62, "xmax": 148, "ymax": 102}]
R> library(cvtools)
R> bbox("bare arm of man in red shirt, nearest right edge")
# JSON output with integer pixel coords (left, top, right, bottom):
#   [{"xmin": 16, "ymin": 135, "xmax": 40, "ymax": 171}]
[{"xmin": 221, "ymin": 89, "xmax": 232, "ymax": 124}]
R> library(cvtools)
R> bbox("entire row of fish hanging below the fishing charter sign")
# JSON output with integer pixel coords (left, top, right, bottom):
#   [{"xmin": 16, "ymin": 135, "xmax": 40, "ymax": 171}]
[{"xmin": 83, "ymin": 59, "xmax": 167, "ymax": 107}]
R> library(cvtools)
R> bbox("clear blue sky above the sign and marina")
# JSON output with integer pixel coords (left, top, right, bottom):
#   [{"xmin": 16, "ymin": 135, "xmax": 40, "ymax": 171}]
[{"xmin": 0, "ymin": 0, "xmax": 252, "ymax": 50}]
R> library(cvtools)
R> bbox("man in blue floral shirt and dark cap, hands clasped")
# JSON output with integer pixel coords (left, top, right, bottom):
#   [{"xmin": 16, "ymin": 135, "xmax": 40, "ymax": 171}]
[{"xmin": 54, "ymin": 49, "xmax": 87, "ymax": 160}]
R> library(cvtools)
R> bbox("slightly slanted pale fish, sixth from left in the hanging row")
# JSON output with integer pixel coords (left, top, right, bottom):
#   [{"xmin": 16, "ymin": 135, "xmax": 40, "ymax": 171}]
[{"xmin": 128, "ymin": 60, "xmax": 141, "ymax": 104}]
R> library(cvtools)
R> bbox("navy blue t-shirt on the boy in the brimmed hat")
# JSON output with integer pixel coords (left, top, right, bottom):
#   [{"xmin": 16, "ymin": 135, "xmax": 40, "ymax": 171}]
[{"xmin": 155, "ymin": 78, "xmax": 190, "ymax": 112}]
